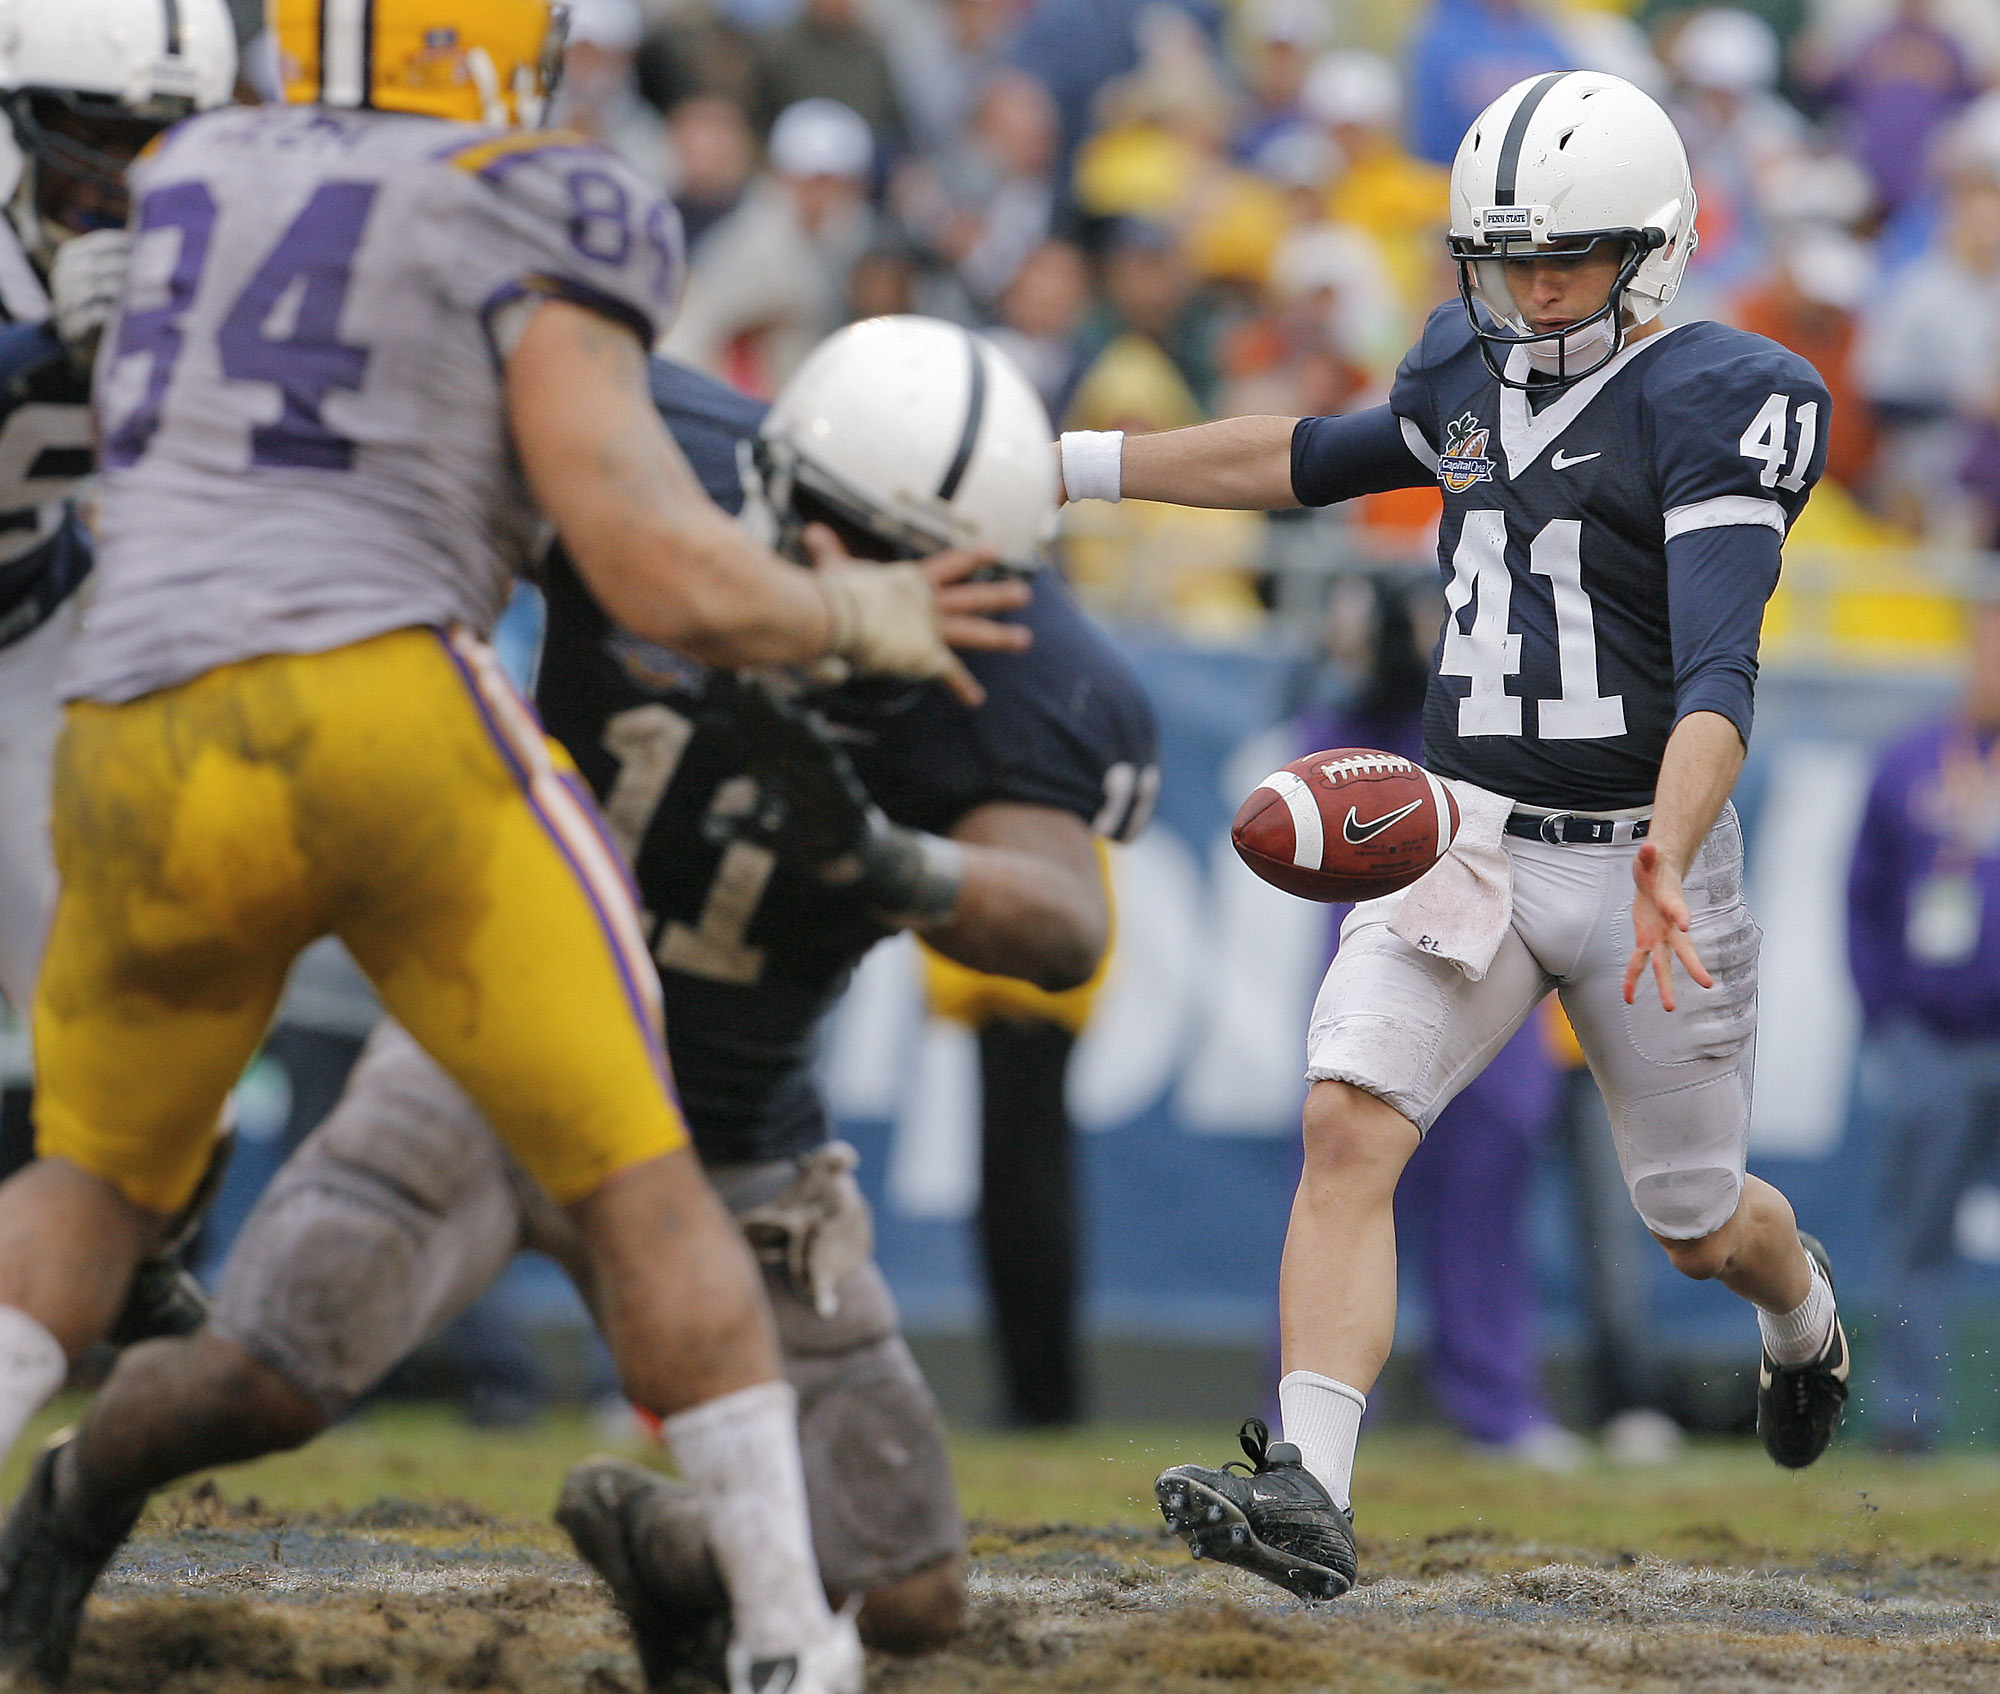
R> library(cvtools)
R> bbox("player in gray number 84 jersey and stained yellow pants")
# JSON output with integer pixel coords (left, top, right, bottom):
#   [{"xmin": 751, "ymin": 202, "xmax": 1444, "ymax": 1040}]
[{"xmin": 0, "ymin": 0, "xmax": 1026, "ymax": 1694}]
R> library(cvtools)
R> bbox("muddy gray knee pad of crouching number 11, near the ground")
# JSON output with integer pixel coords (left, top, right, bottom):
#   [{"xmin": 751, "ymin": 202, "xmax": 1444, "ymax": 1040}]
[{"xmin": 784, "ymin": 1336, "xmax": 966, "ymax": 1592}]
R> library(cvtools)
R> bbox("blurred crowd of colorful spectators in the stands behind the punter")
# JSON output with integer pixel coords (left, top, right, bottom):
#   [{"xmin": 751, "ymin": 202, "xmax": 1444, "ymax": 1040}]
[{"xmin": 544, "ymin": 0, "xmax": 2000, "ymax": 636}]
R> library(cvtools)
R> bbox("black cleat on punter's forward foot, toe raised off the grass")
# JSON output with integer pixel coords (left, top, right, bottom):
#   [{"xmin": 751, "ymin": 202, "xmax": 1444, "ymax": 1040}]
[{"xmin": 1152, "ymin": 1418, "xmax": 1354, "ymax": 1600}]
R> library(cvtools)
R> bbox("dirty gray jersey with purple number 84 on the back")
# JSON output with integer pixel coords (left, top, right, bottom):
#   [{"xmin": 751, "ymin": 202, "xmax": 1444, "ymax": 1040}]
[{"xmin": 64, "ymin": 106, "xmax": 682, "ymax": 700}]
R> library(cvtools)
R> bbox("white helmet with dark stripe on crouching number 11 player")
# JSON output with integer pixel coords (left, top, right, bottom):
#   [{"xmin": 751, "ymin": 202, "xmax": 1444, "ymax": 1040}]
[{"xmin": 740, "ymin": 316, "xmax": 1056, "ymax": 572}]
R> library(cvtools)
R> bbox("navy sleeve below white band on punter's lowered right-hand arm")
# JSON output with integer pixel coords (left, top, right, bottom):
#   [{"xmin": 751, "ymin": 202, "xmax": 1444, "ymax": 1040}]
[{"xmin": 1666, "ymin": 524, "xmax": 1778, "ymax": 746}]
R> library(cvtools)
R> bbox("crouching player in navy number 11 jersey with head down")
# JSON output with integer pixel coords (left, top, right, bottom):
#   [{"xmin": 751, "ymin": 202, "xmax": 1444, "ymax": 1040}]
[{"xmin": 6, "ymin": 318, "xmax": 1156, "ymax": 1686}]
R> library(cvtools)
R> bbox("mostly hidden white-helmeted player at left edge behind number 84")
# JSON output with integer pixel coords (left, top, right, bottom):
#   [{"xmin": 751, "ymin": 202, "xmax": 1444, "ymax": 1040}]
[{"xmin": 0, "ymin": 0, "xmax": 236, "ymax": 1338}]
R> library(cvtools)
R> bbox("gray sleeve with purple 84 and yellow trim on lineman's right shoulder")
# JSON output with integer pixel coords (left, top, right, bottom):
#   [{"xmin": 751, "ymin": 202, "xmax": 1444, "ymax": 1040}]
[{"xmin": 450, "ymin": 136, "xmax": 686, "ymax": 348}]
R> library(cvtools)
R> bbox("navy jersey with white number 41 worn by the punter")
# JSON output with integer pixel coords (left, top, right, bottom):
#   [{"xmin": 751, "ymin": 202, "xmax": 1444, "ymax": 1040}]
[{"xmin": 1390, "ymin": 300, "xmax": 1830, "ymax": 810}]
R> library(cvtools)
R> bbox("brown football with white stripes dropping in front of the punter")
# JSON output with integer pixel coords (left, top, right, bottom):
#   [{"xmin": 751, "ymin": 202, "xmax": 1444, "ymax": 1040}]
[{"xmin": 1230, "ymin": 748, "xmax": 1458, "ymax": 900}]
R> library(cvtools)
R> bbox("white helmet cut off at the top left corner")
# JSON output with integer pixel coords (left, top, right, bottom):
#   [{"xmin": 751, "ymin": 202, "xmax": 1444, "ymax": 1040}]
[{"xmin": 0, "ymin": 0, "xmax": 236, "ymax": 264}]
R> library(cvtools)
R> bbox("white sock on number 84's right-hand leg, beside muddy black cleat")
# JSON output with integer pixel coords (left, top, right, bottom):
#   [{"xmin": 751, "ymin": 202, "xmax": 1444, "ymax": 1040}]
[{"xmin": 662, "ymin": 1382, "xmax": 834, "ymax": 1658}]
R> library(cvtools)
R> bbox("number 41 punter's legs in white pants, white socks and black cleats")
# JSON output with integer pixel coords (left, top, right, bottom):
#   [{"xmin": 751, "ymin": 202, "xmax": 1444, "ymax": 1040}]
[{"xmin": 1156, "ymin": 810, "xmax": 1846, "ymax": 1600}]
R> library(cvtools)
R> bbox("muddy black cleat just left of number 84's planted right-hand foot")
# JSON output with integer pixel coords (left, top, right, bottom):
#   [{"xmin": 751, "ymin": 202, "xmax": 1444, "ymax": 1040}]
[{"xmin": 556, "ymin": 1458, "xmax": 730, "ymax": 1688}]
